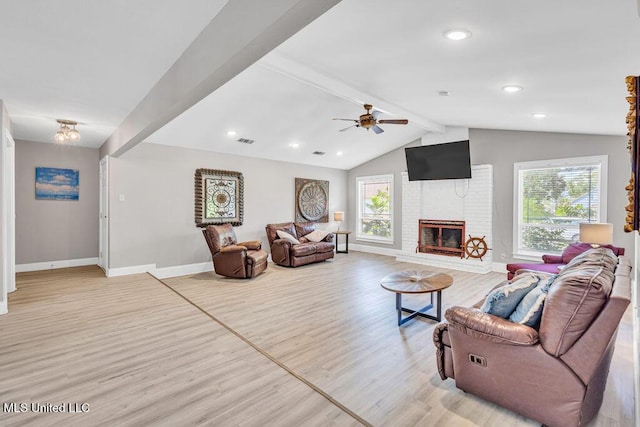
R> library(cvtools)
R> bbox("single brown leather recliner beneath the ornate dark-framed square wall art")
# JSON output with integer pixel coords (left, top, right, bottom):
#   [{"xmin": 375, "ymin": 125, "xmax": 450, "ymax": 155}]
[{"xmin": 202, "ymin": 224, "xmax": 268, "ymax": 279}]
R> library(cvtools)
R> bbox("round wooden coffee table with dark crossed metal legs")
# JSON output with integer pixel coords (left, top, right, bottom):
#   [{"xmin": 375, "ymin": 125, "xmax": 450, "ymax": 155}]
[{"xmin": 380, "ymin": 270, "xmax": 453, "ymax": 326}]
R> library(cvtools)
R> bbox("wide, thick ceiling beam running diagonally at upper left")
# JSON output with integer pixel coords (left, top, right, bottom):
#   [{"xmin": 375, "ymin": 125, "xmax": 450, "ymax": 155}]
[{"xmin": 100, "ymin": 0, "xmax": 340, "ymax": 158}]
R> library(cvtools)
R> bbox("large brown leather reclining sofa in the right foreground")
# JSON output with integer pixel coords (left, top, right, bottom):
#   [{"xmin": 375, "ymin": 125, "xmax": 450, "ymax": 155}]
[{"xmin": 433, "ymin": 248, "xmax": 631, "ymax": 427}]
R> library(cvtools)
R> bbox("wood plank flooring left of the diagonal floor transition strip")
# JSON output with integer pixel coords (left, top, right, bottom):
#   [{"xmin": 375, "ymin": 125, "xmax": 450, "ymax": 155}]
[{"xmin": 0, "ymin": 267, "xmax": 359, "ymax": 426}]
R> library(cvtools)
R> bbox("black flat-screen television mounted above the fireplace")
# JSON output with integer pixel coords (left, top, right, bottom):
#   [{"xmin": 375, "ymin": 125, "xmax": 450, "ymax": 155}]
[{"xmin": 404, "ymin": 140, "xmax": 471, "ymax": 181}]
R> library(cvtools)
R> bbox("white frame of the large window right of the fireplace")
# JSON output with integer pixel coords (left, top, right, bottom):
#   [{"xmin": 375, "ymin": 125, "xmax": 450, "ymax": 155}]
[{"xmin": 513, "ymin": 155, "xmax": 609, "ymax": 261}]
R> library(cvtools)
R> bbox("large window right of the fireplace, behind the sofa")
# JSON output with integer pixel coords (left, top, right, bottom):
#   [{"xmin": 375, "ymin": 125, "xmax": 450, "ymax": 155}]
[{"xmin": 513, "ymin": 156, "xmax": 607, "ymax": 257}]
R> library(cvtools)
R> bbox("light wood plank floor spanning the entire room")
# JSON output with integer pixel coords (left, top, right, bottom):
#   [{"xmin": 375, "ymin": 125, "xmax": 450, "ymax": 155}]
[{"xmin": 0, "ymin": 251, "xmax": 633, "ymax": 427}]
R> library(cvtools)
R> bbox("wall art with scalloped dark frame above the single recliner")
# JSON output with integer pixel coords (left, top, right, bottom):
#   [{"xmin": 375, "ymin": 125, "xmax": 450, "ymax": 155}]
[{"xmin": 195, "ymin": 169, "xmax": 244, "ymax": 227}]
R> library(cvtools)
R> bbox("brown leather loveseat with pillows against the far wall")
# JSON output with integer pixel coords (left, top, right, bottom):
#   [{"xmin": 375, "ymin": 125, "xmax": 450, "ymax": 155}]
[{"xmin": 265, "ymin": 222, "xmax": 335, "ymax": 267}]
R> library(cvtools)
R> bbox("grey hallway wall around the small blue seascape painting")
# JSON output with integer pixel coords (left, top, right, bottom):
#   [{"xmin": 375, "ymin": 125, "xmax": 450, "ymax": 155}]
[{"xmin": 16, "ymin": 140, "xmax": 99, "ymax": 264}]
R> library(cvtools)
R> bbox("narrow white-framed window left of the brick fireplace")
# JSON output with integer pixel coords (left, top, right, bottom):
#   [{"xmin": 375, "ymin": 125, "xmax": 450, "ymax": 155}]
[{"xmin": 356, "ymin": 175, "xmax": 393, "ymax": 243}]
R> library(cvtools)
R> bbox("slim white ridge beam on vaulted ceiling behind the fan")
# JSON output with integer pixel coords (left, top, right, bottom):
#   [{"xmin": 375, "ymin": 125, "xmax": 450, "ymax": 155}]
[{"xmin": 257, "ymin": 51, "xmax": 444, "ymax": 133}]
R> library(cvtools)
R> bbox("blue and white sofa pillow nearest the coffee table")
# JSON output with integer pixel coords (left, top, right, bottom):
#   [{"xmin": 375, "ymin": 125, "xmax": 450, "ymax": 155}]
[{"xmin": 480, "ymin": 272, "xmax": 540, "ymax": 319}]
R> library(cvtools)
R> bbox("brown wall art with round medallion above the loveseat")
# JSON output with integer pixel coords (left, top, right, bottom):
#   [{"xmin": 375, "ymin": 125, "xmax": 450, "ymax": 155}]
[{"xmin": 295, "ymin": 178, "xmax": 329, "ymax": 222}]
